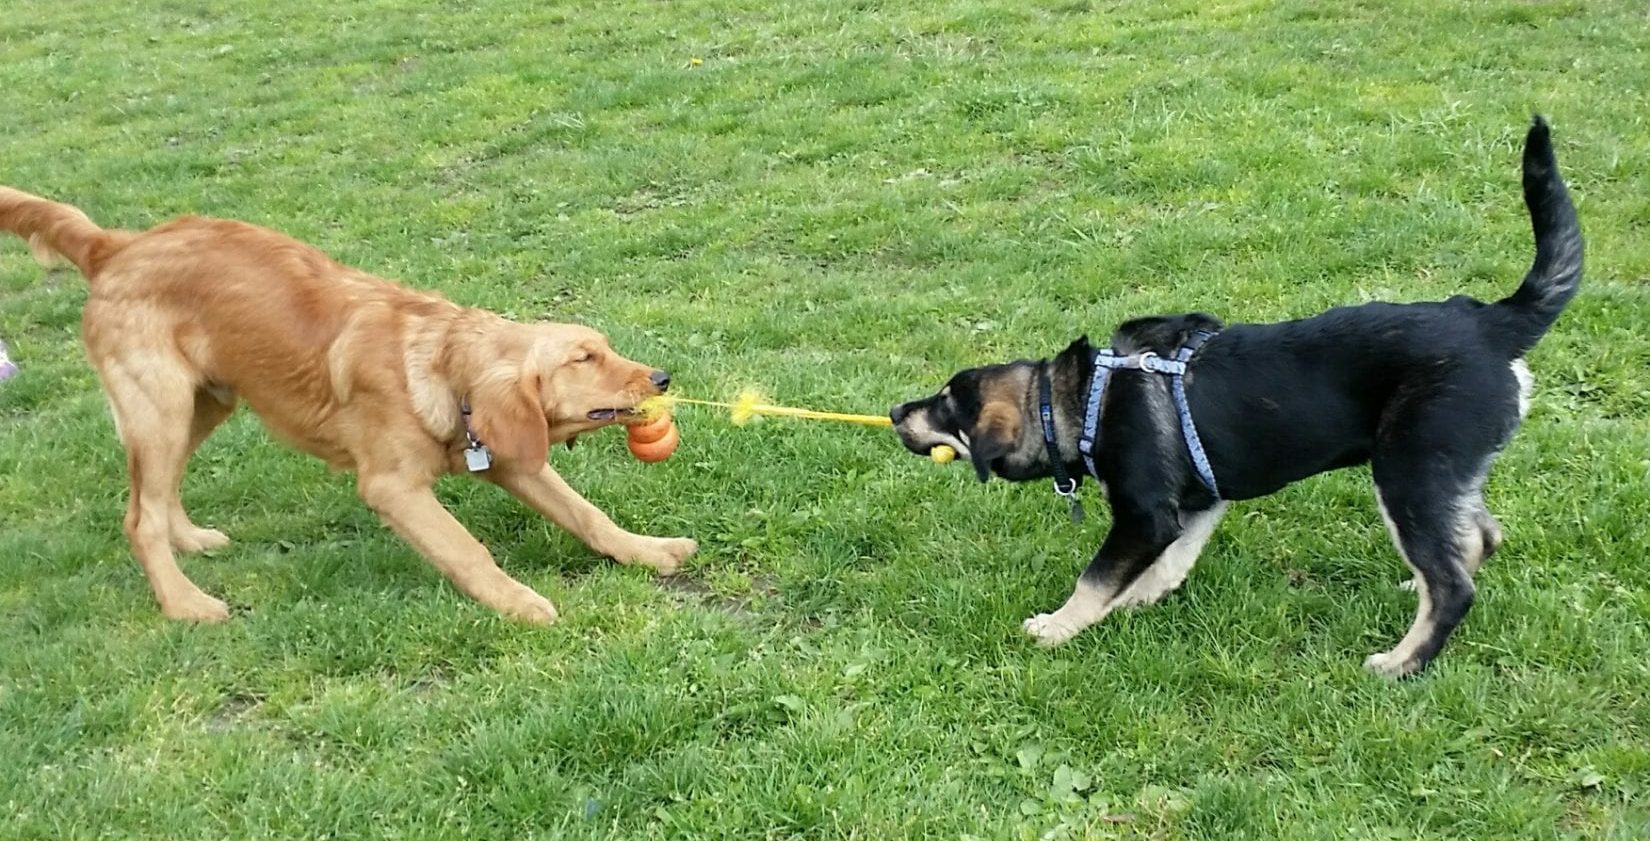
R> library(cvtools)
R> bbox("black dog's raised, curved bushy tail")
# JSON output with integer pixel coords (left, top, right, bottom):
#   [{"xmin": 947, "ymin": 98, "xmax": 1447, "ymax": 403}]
[{"xmin": 1487, "ymin": 115, "xmax": 1582, "ymax": 358}]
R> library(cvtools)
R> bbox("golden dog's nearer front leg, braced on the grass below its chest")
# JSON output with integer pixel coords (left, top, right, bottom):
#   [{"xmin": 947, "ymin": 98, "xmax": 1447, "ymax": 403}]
[{"xmin": 358, "ymin": 473, "xmax": 556, "ymax": 625}]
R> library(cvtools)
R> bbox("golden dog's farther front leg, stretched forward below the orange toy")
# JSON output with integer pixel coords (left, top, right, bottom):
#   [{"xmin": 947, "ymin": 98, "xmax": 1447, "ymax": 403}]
[{"xmin": 482, "ymin": 465, "xmax": 700, "ymax": 576}]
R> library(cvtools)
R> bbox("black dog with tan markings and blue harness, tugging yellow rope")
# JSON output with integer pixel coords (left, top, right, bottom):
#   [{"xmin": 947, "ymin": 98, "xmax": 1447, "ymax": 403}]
[{"xmin": 891, "ymin": 117, "xmax": 1582, "ymax": 676}]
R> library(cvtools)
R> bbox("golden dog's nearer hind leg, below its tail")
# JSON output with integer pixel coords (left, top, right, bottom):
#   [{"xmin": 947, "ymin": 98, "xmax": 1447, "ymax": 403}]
[{"xmin": 96, "ymin": 353, "xmax": 229, "ymax": 622}]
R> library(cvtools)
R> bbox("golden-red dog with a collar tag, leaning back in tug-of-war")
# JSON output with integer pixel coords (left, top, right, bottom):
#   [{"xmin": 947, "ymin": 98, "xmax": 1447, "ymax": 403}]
[{"xmin": 0, "ymin": 186, "xmax": 696, "ymax": 622}]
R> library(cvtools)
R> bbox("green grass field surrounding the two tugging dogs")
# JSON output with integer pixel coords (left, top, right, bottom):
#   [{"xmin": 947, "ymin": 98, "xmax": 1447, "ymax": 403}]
[{"xmin": 0, "ymin": 0, "xmax": 1650, "ymax": 839}]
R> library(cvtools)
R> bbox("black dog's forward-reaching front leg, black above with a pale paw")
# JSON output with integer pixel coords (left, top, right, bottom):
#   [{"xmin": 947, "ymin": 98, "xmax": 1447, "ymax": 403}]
[{"xmin": 1025, "ymin": 508, "xmax": 1180, "ymax": 646}]
